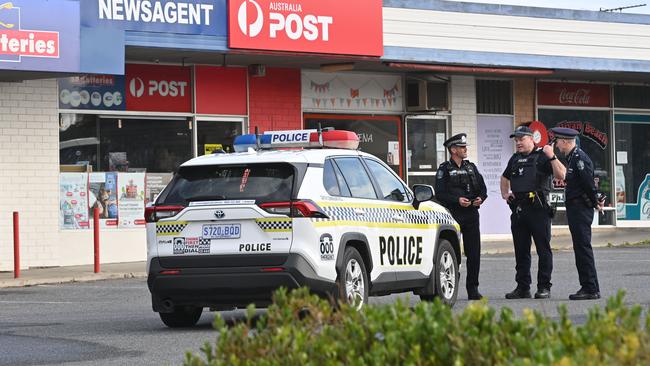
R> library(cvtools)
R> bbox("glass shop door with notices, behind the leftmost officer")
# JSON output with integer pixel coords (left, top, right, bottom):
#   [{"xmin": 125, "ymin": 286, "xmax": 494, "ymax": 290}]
[{"xmin": 406, "ymin": 115, "xmax": 447, "ymax": 186}]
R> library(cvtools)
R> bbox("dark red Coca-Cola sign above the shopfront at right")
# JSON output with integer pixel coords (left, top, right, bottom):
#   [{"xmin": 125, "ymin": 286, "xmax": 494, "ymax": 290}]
[{"xmin": 537, "ymin": 82, "xmax": 609, "ymax": 107}]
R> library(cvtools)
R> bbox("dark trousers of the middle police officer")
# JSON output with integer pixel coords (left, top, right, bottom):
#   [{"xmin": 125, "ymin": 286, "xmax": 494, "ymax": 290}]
[{"xmin": 510, "ymin": 206, "xmax": 553, "ymax": 289}]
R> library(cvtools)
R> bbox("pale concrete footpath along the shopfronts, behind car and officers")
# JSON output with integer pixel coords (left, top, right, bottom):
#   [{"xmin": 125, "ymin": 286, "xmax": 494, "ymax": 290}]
[{"xmin": 0, "ymin": 227, "xmax": 650, "ymax": 288}]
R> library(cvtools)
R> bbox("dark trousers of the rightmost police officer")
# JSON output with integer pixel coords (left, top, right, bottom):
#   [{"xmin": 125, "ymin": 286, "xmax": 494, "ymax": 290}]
[{"xmin": 566, "ymin": 202, "xmax": 600, "ymax": 293}]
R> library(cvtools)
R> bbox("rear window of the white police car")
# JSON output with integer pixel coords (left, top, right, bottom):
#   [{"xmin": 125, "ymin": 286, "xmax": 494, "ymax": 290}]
[{"xmin": 156, "ymin": 163, "xmax": 295, "ymax": 206}]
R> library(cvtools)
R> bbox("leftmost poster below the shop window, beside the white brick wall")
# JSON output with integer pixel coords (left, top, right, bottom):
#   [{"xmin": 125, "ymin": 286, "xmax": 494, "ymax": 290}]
[{"xmin": 59, "ymin": 173, "xmax": 90, "ymax": 230}]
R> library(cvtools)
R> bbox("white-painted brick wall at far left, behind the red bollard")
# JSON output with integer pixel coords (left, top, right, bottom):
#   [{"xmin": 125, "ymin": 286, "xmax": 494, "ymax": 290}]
[{"xmin": 0, "ymin": 80, "xmax": 59, "ymax": 271}]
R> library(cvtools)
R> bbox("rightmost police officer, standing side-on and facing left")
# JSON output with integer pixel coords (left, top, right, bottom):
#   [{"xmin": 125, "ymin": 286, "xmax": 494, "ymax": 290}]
[{"xmin": 551, "ymin": 127, "xmax": 605, "ymax": 300}]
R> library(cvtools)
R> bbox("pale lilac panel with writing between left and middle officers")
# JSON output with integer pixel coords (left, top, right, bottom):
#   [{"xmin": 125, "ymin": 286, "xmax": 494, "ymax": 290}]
[{"xmin": 470, "ymin": 116, "xmax": 514, "ymax": 234}]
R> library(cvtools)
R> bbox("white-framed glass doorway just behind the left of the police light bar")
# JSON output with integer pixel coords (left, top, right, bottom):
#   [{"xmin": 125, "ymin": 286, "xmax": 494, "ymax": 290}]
[{"xmin": 195, "ymin": 117, "xmax": 244, "ymax": 156}]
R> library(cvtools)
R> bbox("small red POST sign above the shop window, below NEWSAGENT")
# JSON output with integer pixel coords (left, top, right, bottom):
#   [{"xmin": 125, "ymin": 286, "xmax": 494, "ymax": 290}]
[{"xmin": 126, "ymin": 64, "xmax": 192, "ymax": 112}]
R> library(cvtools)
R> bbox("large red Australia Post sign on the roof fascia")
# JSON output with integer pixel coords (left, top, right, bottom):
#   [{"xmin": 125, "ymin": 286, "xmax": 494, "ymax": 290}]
[{"xmin": 228, "ymin": 0, "xmax": 383, "ymax": 56}]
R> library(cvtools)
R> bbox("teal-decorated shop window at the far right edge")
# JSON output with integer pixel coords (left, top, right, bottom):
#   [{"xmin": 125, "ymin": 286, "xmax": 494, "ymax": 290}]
[{"xmin": 614, "ymin": 114, "xmax": 650, "ymax": 220}]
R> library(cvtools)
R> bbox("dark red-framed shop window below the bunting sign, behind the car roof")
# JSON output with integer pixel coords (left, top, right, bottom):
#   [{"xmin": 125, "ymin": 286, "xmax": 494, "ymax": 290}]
[{"xmin": 305, "ymin": 115, "xmax": 402, "ymax": 175}]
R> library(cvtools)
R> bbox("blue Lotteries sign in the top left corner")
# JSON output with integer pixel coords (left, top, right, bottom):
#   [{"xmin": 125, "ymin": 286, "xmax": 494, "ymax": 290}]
[{"xmin": 0, "ymin": 0, "xmax": 80, "ymax": 72}]
